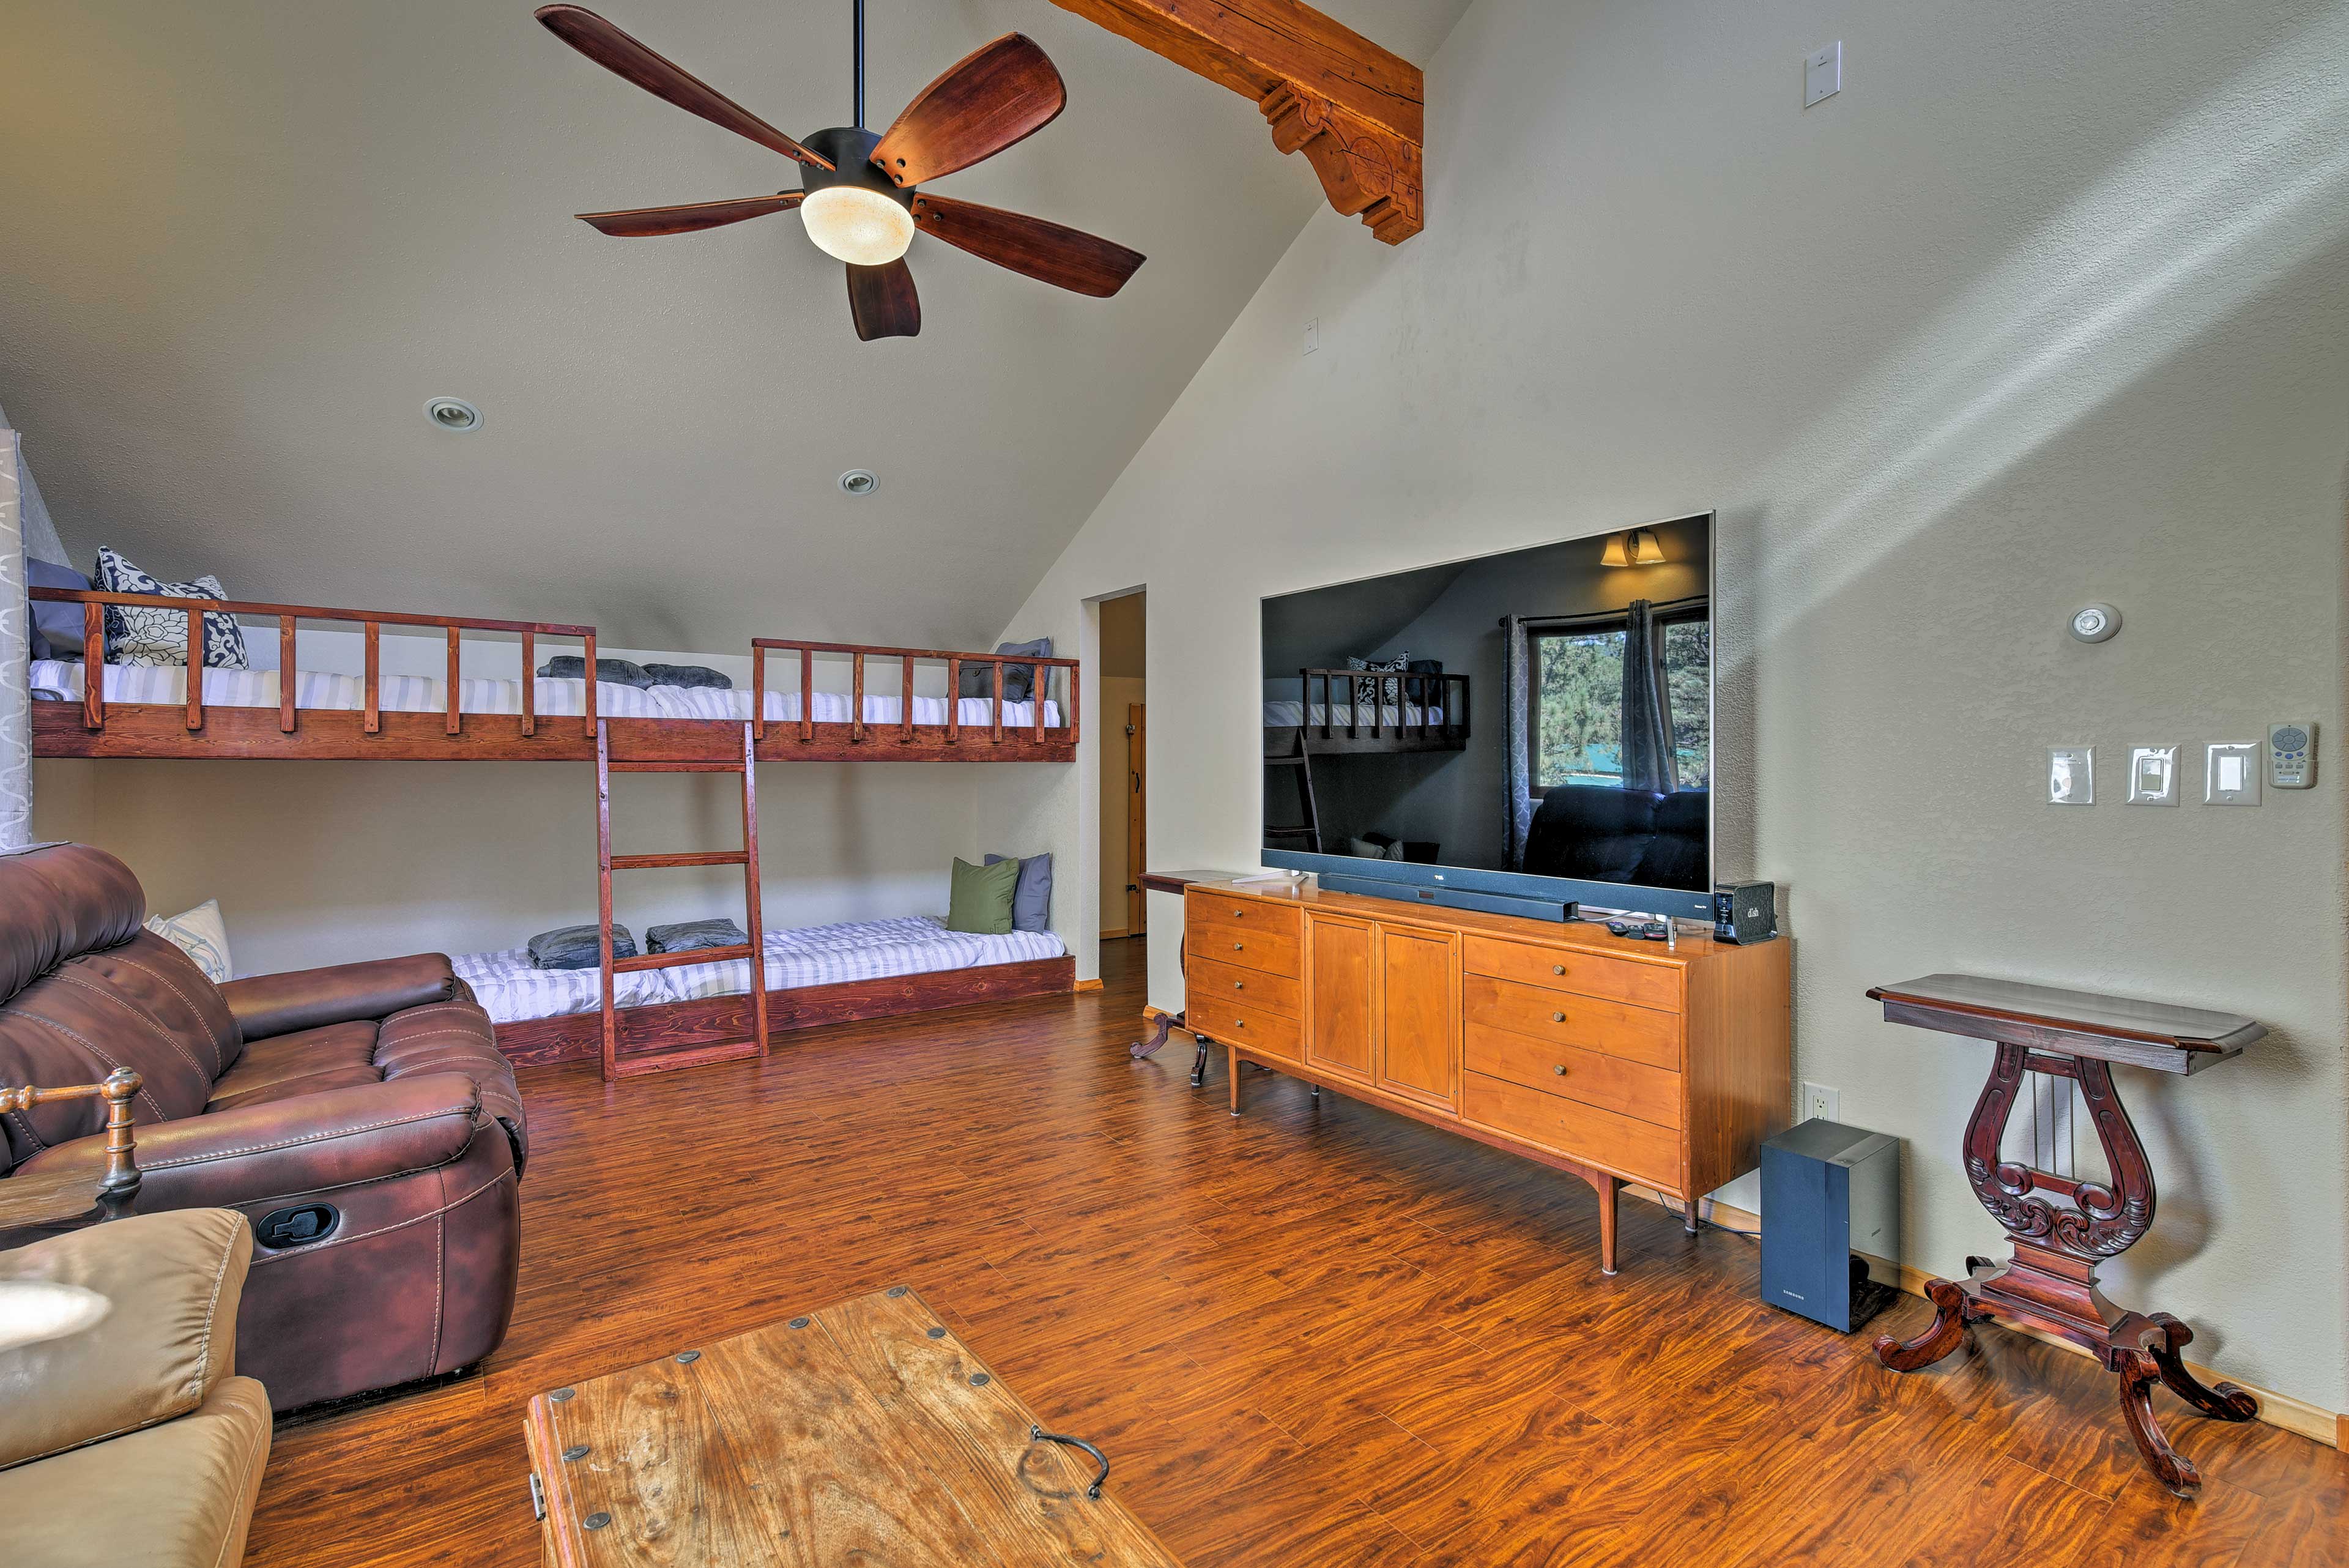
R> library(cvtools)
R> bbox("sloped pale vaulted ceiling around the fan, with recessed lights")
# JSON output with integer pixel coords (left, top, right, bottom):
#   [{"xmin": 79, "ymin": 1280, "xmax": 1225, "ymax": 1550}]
[{"xmin": 0, "ymin": 0, "xmax": 1468, "ymax": 651}]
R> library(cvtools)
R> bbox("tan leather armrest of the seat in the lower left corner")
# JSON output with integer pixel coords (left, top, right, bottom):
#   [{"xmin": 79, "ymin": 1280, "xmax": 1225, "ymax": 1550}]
[{"xmin": 0, "ymin": 1208, "xmax": 254, "ymax": 1470}]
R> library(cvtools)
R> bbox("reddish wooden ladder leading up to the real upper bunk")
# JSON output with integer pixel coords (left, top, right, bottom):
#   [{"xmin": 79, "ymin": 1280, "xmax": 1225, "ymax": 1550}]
[{"xmin": 595, "ymin": 719, "xmax": 766, "ymax": 1083}]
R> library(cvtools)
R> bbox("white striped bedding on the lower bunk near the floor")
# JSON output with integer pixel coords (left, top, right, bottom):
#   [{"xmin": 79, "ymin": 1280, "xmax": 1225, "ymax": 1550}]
[{"xmin": 451, "ymin": 912, "xmax": 1066, "ymax": 1023}]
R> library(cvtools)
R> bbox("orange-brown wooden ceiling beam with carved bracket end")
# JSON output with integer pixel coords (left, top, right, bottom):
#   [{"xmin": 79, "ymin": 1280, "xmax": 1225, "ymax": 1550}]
[{"xmin": 1052, "ymin": 0, "xmax": 1426, "ymax": 245}]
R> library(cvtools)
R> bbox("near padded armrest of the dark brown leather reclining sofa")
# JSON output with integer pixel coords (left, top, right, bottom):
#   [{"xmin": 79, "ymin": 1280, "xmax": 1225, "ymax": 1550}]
[{"xmin": 9, "ymin": 1072, "xmax": 486, "ymax": 1211}]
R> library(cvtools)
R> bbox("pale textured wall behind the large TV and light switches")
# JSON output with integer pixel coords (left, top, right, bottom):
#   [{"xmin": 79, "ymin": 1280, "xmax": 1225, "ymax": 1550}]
[{"xmin": 982, "ymin": 0, "xmax": 2349, "ymax": 1411}]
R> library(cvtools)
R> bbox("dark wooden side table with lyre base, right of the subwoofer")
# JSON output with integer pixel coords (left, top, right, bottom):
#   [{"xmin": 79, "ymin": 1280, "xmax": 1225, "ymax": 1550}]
[{"xmin": 1868, "ymin": 976, "xmax": 2267, "ymax": 1498}]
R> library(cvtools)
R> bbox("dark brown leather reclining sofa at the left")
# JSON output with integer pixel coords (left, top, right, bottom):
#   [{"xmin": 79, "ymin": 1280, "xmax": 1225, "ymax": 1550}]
[{"xmin": 0, "ymin": 844, "xmax": 526, "ymax": 1411}]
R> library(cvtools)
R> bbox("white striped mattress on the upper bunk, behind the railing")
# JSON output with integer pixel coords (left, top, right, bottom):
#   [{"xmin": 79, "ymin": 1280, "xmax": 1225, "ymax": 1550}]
[{"xmin": 33, "ymin": 658, "xmax": 1059, "ymax": 729}]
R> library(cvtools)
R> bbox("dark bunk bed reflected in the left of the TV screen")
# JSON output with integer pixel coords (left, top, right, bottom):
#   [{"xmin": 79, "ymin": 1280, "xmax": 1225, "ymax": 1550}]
[{"xmin": 1264, "ymin": 667, "xmax": 1468, "ymax": 853}]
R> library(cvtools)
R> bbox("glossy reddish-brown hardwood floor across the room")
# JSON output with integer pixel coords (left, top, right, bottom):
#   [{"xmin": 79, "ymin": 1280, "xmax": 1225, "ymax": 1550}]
[{"xmin": 247, "ymin": 940, "xmax": 2349, "ymax": 1568}]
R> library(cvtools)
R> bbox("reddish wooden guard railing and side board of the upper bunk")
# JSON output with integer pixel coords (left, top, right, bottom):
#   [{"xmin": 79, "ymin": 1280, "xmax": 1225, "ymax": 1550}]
[{"xmin": 31, "ymin": 588, "xmax": 1078, "ymax": 764}]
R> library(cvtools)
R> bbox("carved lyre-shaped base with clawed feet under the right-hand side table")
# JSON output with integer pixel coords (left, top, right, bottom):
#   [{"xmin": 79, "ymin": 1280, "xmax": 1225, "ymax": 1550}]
[{"xmin": 1877, "ymin": 1041, "xmax": 2260, "ymax": 1498}]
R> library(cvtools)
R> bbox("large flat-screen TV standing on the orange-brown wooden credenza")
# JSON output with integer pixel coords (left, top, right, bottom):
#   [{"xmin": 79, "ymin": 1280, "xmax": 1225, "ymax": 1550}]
[{"xmin": 1264, "ymin": 515, "xmax": 1715, "ymax": 919}]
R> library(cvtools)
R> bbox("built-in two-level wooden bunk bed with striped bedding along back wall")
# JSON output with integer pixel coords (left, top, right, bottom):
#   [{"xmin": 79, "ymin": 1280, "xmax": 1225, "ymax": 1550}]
[{"xmin": 33, "ymin": 588, "xmax": 1078, "ymax": 1077}]
